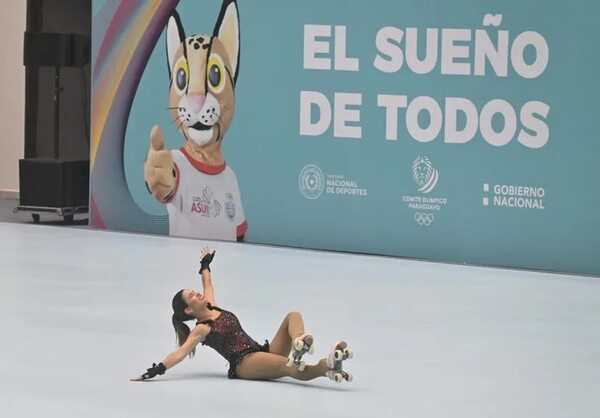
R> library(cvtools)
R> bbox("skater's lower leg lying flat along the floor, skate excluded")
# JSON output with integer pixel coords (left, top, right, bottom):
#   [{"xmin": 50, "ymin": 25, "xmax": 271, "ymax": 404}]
[{"xmin": 236, "ymin": 352, "xmax": 329, "ymax": 380}]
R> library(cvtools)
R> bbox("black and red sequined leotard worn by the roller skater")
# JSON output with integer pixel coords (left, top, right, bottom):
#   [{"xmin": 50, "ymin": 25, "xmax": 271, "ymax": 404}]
[{"xmin": 198, "ymin": 306, "xmax": 269, "ymax": 379}]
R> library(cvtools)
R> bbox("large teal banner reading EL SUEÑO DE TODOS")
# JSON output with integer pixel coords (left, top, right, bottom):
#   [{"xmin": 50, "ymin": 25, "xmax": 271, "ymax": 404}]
[{"xmin": 91, "ymin": 0, "xmax": 600, "ymax": 275}]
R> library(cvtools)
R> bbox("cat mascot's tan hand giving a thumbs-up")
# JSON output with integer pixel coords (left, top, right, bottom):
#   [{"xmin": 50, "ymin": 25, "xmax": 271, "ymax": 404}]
[{"xmin": 144, "ymin": 125, "xmax": 177, "ymax": 203}]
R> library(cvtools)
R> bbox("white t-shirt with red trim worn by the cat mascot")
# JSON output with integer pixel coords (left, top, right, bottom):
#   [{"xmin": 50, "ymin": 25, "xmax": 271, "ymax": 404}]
[{"xmin": 167, "ymin": 149, "xmax": 248, "ymax": 241}]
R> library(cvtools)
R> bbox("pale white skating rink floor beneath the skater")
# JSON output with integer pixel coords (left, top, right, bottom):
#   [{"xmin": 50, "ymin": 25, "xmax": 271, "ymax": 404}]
[{"xmin": 0, "ymin": 223, "xmax": 600, "ymax": 418}]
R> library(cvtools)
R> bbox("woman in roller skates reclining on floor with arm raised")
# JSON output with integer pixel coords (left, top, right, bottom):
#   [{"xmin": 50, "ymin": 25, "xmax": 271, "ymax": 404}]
[{"xmin": 131, "ymin": 247, "xmax": 352, "ymax": 382}]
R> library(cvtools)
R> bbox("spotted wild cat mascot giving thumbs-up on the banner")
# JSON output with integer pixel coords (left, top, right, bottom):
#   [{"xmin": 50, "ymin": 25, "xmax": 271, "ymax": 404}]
[{"xmin": 144, "ymin": 0, "xmax": 248, "ymax": 241}]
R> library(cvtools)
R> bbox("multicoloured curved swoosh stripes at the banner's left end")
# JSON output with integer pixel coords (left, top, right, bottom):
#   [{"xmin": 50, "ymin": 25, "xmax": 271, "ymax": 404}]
[{"xmin": 90, "ymin": 0, "xmax": 179, "ymax": 234}]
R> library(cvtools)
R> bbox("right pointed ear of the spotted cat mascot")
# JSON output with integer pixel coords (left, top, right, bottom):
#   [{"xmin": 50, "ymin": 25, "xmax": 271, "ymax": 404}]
[{"xmin": 213, "ymin": 0, "xmax": 240, "ymax": 83}]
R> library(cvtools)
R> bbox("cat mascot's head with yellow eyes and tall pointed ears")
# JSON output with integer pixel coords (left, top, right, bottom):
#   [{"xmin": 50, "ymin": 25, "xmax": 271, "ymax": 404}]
[{"xmin": 167, "ymin": 1, "xmax": 240, "ymax": 146}]
